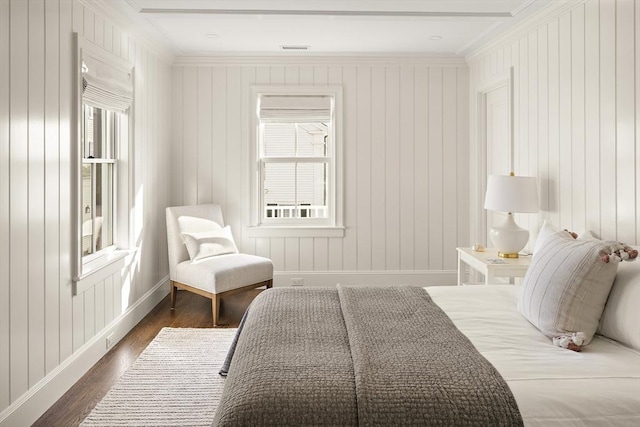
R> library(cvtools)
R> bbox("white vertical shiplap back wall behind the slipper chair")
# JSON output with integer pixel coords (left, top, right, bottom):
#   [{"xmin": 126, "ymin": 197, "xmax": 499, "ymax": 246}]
[{"xmin": 171, "ymin": 58, "xmax": 469, "ymax": 280}]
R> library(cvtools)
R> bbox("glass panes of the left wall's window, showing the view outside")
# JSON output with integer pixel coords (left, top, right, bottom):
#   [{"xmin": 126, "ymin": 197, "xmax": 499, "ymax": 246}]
[{"xmin": 80, "ymin": 104, "xmax": 120, "ymax": 256}]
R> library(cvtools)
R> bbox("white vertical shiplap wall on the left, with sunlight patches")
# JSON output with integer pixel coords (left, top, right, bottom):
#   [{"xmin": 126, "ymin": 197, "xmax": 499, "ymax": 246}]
[{"xmin": 0, "ymin": 0, "xmax": 171, "ymax": 412}]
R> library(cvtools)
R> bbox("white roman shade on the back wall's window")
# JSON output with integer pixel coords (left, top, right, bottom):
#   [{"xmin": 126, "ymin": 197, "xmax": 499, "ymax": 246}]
[{"xmin": 258, "ymin": 95, "xmax": 331, "ymax": 122}]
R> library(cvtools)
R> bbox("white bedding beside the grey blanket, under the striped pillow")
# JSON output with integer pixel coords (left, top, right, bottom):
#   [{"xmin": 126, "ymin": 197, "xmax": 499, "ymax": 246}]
[{"xmin": 426, "ymin": 285, "xmax": 640, "ymax": 427}]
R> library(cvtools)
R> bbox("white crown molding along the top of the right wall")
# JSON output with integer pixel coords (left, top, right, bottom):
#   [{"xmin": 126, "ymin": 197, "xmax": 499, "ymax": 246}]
[{"xmin": 465, "ymin": 0, "xmax": 589, "ymax": 63}]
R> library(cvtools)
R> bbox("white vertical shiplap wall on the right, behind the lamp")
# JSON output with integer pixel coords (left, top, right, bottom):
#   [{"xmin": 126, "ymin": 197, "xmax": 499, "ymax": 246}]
[{"xmin": 469, "ymin": 0, "xmax": 640, "ymax": 249}]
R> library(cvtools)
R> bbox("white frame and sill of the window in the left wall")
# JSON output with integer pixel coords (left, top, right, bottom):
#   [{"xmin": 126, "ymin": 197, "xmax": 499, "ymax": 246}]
[{"xmin": 71, "ymin": 33, "xmax": 135, "ymax": 288}]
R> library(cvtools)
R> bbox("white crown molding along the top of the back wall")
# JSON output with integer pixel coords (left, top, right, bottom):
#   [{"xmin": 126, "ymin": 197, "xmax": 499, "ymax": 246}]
[{"xmin": 174, "ymin": 53, "xmax": 467, "ymax": 67}]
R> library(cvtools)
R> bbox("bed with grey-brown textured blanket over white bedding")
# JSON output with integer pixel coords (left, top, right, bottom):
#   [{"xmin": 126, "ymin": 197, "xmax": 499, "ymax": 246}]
[{"xmin": 214, "ymin": 236, "xmax": 640, "ymax": 426}]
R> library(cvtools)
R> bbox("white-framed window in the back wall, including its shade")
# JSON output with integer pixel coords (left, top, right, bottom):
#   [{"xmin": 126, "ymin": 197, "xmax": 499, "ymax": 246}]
[{"xmin": 252, "ymin": 86, "xmax": 342, "ymax": 236}]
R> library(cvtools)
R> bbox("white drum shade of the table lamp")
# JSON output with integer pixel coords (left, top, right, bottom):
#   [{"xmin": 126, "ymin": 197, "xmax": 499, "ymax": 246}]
[{"xmin": 484, "ymin": 175, "xmax": 538, "ymax": 213}]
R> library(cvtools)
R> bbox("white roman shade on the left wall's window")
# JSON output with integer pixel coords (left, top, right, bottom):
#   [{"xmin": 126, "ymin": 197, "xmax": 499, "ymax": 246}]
[{"xmin": 82, "ymin": 52, "xmax": 133, "ymax": 112}]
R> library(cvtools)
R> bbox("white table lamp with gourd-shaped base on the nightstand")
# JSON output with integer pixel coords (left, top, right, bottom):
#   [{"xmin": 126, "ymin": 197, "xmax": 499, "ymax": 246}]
[{"xmin": 484, "ymin": 173, "xmax": 538, "ymax": 258}]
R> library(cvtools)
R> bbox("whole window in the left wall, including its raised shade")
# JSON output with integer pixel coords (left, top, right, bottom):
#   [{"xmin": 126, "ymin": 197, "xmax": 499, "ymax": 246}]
[{"xmin": 74, "ymin": 38, "xmax": 133, "ymax": 284}]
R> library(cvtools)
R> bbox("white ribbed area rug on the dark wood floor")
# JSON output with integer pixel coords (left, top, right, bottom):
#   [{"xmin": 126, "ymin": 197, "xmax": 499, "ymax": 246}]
[{"xmin": 80, "ymin": 328, "xmax": 236, "ymax": 427}]
